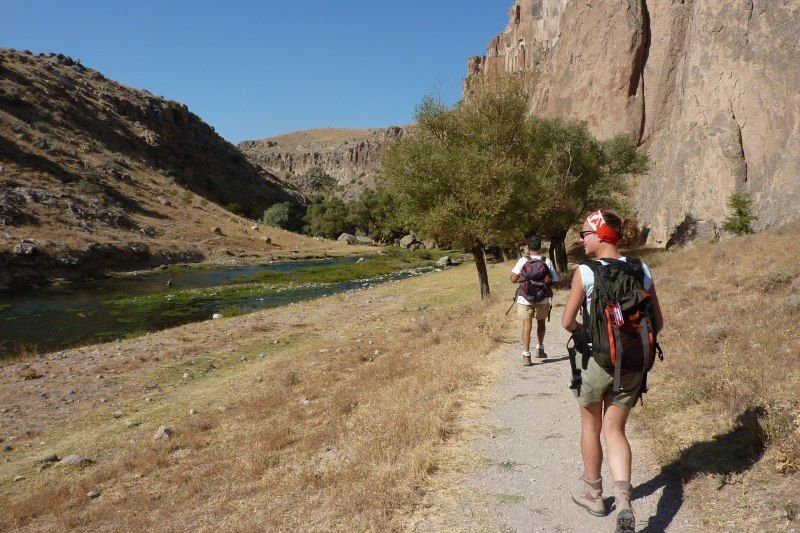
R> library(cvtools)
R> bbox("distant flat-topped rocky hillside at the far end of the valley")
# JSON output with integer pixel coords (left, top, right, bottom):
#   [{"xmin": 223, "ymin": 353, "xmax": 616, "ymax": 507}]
[{"xmin": 239, "ymin": 126, "xmax": 407, "ymax": 200}]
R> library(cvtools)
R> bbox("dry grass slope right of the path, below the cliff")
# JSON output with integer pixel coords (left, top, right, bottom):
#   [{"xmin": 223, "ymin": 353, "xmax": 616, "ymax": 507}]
[{"xmin": 642, "ymin": 219, "xmax": 800, "ymax": 531}]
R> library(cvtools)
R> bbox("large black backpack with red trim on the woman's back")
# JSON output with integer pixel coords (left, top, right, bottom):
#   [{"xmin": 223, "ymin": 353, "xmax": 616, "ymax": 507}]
[{"xmin": 581, "ymin": 258, "xmax": 663, "ymax": 395}]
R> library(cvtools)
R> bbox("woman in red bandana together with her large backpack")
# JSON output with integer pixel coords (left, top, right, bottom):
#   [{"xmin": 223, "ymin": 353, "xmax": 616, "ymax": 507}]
[{"xmin": 562, "ymin": 210, "xmax": 664, "ymax": 533}]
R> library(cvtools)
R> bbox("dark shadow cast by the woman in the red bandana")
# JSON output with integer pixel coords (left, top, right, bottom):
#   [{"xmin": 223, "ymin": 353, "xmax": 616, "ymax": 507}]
[{"xmin": 633, "ymin": 407, "xmax": 765, "ymax": 533}]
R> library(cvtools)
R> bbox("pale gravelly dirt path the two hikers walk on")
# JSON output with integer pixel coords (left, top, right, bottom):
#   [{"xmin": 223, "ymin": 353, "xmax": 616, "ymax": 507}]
[{"xmin": 415, "ymin": 300, "xmax": 698, "ymax": 532}]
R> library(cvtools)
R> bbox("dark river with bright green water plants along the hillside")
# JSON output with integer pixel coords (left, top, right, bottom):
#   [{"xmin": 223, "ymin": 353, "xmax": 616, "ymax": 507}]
[{"xmin": 0, "ymin": 247, "xmax": 456, "ymax": 359}]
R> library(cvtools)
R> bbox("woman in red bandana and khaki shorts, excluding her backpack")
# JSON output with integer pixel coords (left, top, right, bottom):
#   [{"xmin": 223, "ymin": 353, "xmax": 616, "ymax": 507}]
[{"xmin": 562, "ymin": 210, "xmax": 664, "ymax": 533}]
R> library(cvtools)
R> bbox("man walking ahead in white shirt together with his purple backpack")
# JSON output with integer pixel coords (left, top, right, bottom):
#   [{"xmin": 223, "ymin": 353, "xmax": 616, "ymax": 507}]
[{"xmin": 511, "ymin": 237, "xmax": 558, "ymax": 366}]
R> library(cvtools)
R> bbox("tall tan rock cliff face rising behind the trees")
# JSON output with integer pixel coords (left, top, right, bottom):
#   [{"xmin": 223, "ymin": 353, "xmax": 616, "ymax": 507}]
[{"xmin": 468, "ymin": 0, "xmax": 800, "ymax": 244}]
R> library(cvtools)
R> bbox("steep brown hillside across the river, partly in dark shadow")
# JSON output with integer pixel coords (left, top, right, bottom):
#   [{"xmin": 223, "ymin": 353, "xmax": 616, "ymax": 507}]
[{"xmin": 0, "ymin": 50, "xmax": 354, "ymax": 289}]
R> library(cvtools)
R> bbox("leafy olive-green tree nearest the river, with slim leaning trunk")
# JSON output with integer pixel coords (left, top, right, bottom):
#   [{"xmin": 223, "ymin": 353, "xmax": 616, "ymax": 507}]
[{"xmin": 379, "ymin": 77, "xmax": 528, "ymax": 298}]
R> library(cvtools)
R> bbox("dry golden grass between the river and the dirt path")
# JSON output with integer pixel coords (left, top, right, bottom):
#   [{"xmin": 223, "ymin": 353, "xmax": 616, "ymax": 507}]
[{"xmin": 0, "ymin": 265, "xmax": 505, "ymax": 531}]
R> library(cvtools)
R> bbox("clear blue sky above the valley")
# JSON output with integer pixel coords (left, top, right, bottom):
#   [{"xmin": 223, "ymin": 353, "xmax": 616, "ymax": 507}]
[{"xmin": 0, "ymin": 0, "xmax": 511, "ymax": 143}]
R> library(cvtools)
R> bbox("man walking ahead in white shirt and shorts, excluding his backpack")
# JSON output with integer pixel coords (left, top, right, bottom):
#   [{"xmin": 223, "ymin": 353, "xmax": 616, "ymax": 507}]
[{"xmin": 511, "ymin": 237, "xmax": 558, "ymax": 366}]
